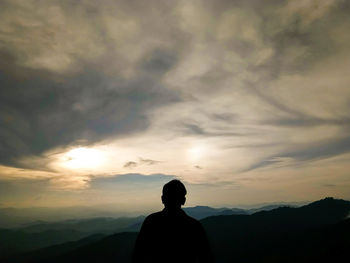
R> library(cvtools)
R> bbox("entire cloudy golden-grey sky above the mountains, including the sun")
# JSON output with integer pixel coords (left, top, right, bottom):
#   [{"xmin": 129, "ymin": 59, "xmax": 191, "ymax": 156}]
[{"xmin": 0, "ymin": 0, "xmax": 350, "ymax": 210}]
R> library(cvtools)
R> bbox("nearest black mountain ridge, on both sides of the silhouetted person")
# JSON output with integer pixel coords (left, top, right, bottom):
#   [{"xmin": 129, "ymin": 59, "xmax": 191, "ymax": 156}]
[{"xmin": 6, "ymin": 198, "xmax": 350, "ymax": 263}]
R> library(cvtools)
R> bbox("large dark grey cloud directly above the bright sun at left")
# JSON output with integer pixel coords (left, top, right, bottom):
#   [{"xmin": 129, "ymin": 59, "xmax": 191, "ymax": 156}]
[{"xmin": 0, "ymin": 50, "xmax": 179, "ymax": 168}]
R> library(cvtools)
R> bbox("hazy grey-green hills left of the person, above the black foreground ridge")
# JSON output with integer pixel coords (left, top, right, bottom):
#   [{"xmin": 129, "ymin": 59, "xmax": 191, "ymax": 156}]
[{"xmin": 0, "ymin": 216, "xmax": 144, "ymax": 256}]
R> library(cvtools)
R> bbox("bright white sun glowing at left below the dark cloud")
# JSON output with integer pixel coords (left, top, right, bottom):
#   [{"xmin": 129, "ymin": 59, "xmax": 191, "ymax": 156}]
[{"xmin": 64, "ymin": 147, "xmax": 104, "ymax": 169}]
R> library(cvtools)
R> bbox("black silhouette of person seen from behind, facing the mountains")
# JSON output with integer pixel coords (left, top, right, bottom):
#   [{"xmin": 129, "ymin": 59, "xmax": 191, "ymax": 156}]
[{"xmin": 133, "ymin": 180, "xmax": 212, "ymax": 263}]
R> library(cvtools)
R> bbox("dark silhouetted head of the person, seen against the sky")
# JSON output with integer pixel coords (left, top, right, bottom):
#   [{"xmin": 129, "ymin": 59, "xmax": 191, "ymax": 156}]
[{"xmin": 162, "ymin": 180, "xmax": 187, "ymax": 208}]
